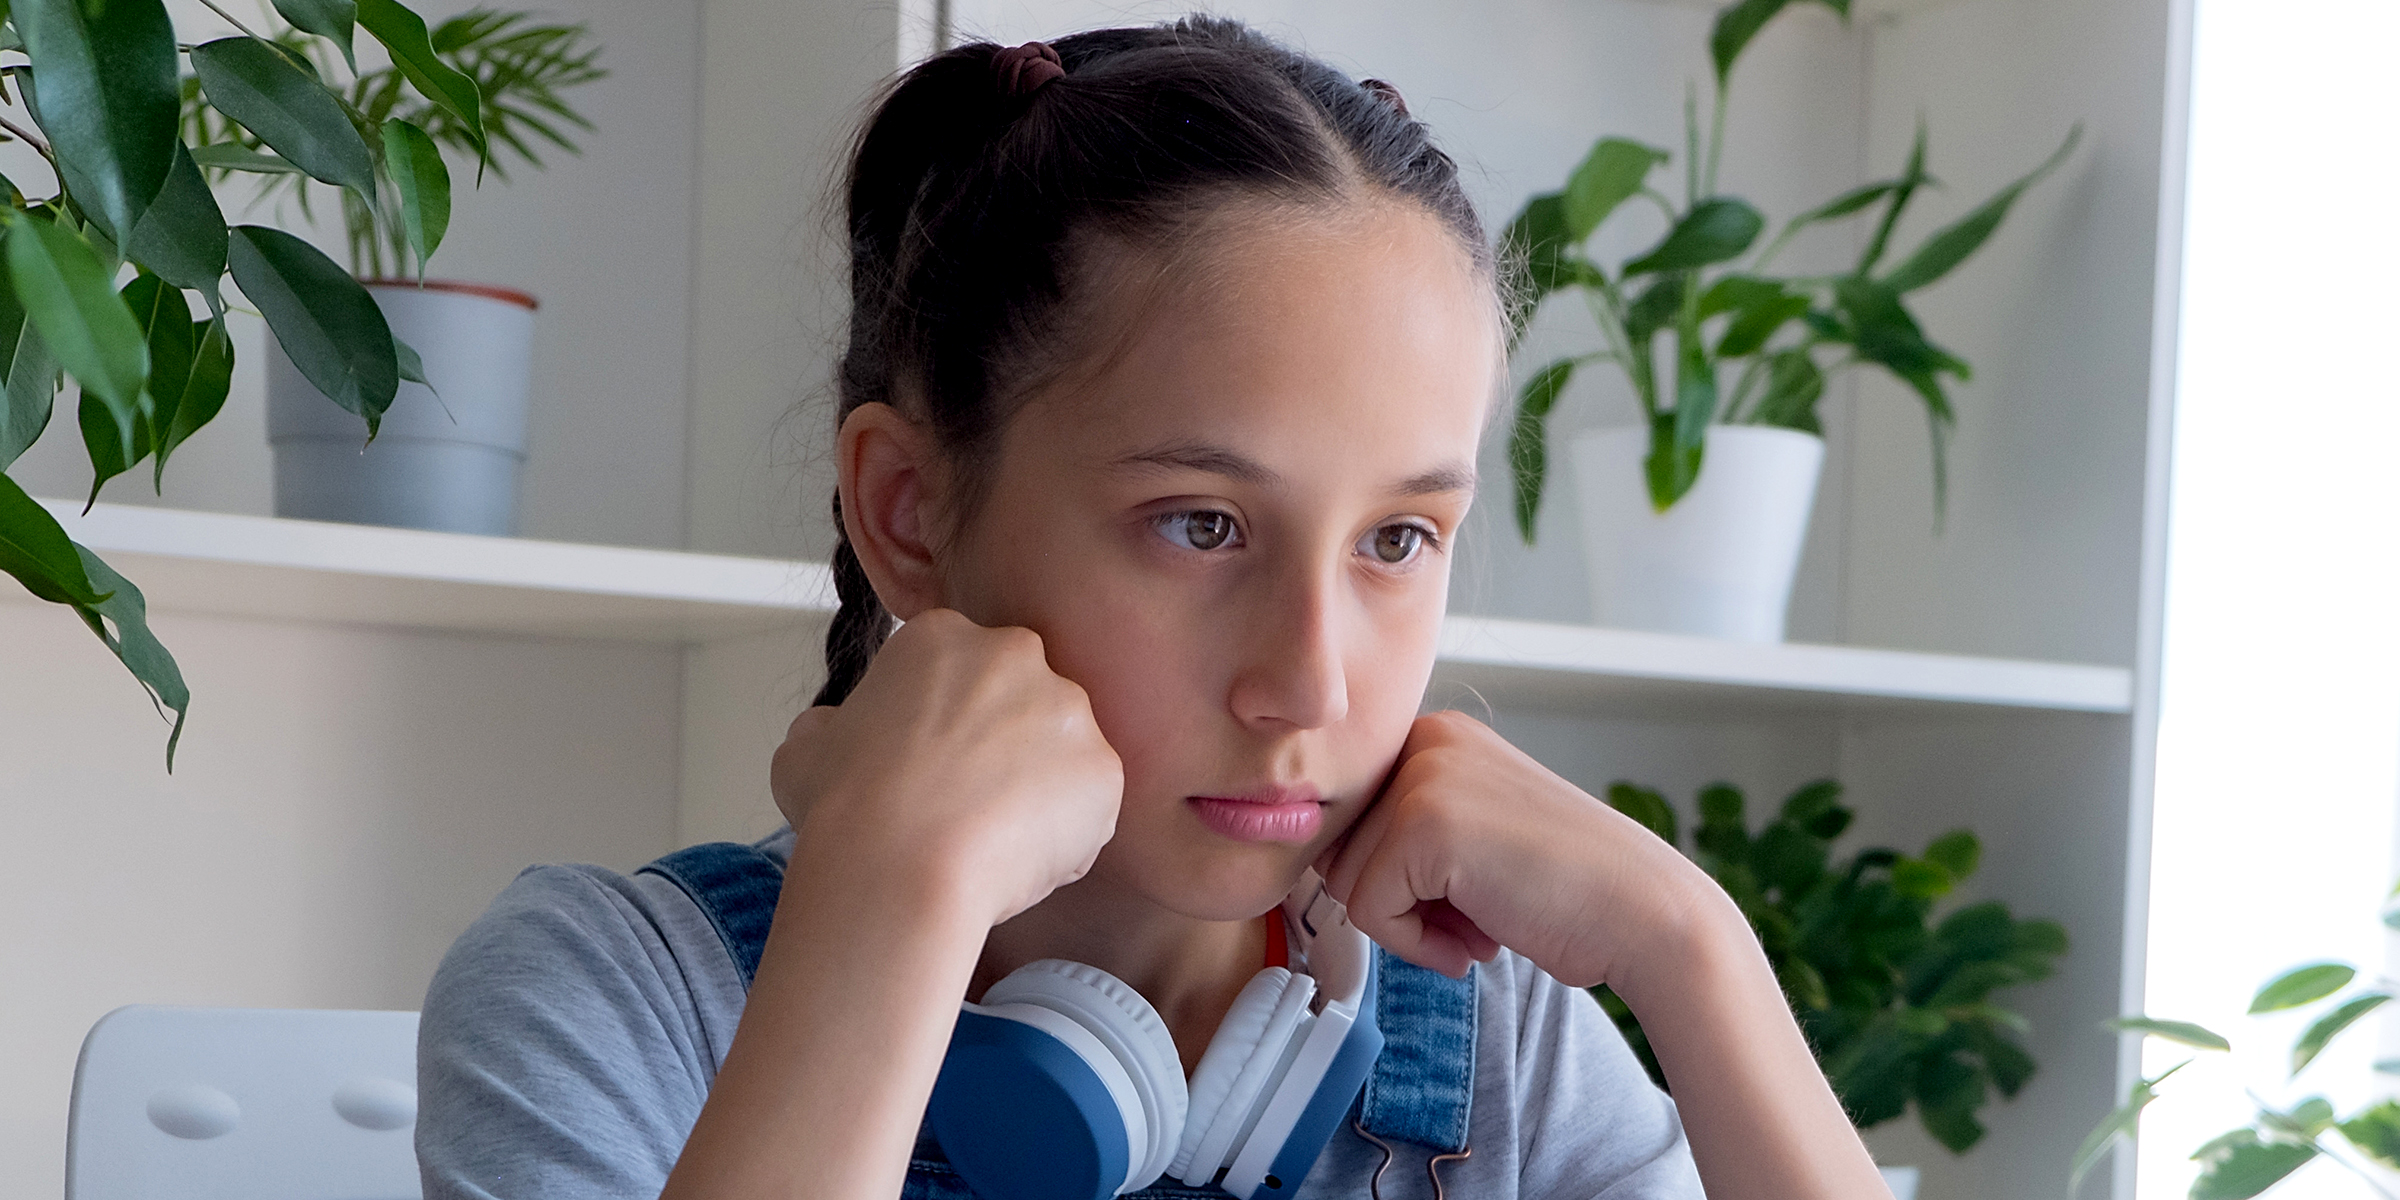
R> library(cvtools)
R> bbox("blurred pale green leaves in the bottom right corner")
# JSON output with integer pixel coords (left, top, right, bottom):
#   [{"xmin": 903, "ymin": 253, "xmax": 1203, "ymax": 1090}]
[{"xmin": 2066, "ymin": 888, "xmax": 2400, "ymax": 1200}]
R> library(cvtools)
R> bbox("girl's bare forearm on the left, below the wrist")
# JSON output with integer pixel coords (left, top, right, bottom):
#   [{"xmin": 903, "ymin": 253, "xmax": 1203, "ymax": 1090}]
[{"xmin": 662, "ymin": 838, "xmax": 989, "ymax": 1200}]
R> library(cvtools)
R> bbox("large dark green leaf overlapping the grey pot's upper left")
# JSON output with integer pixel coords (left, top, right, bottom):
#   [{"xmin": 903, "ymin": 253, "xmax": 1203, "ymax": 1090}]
[{"xmin": 230, "ymin": 226, "xmax": 401, "ymax": 442}]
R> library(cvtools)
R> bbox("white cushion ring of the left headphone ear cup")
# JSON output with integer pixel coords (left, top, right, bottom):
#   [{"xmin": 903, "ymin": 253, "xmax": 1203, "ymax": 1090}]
[{"xmin": 982, "ymin": 958, "xmax": 1188, "ymax": 1190}]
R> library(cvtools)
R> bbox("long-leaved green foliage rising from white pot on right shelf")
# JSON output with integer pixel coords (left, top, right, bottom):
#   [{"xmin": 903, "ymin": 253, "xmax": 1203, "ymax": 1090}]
[{"xmin": 1502, "ymin": 0, "xmax": 2083, "ymax": 535}]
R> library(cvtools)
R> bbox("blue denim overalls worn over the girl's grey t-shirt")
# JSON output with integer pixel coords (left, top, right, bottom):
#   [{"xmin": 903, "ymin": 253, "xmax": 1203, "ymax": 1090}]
[{"xmin": 643, "ymin": 842, "xmax": 1476, "ymax": 1200}]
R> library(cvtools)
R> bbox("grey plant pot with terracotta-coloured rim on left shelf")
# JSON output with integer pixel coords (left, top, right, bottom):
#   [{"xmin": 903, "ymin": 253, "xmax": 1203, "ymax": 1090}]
[{"xmin": 266, "ymin": 281, "xmax": 535, "ymax": 538}]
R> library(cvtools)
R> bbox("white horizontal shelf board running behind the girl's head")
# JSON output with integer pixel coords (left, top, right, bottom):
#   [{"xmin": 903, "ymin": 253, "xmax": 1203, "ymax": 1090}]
[{"xmin": 14, "ymin": 502, "xmax": 2131, "ymax": 715}]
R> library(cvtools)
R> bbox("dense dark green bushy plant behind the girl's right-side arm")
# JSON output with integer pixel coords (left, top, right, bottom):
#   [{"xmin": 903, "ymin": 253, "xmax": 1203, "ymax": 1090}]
[{"xmin": 1594, "ymin": 780, "xmax": 2066, "ymax": 1200}]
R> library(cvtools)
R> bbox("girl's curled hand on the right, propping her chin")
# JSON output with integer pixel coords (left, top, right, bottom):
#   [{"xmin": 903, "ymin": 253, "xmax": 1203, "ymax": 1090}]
[{"xmin": 1318, "ymin": 713, "xmax": 1721, "ymax": 986}]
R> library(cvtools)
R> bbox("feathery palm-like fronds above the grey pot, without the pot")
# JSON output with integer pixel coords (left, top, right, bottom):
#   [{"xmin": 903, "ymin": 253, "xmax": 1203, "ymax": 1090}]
[{"xmin": 182, "ymin": 7, "xmax": 607, "ymax": 278}]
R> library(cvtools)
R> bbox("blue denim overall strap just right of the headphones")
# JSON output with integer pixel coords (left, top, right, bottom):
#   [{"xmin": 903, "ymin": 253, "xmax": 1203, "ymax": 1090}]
[{"xmin": 1358, "ymin": 946, "xmax": 1476, "ymax": 1154}]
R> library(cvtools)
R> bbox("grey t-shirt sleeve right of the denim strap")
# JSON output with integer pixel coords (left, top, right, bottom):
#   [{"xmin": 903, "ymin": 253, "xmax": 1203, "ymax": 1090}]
[{"xmin": 1507, "ymin": 955, "xmax": 1702, "ymax": 1200}]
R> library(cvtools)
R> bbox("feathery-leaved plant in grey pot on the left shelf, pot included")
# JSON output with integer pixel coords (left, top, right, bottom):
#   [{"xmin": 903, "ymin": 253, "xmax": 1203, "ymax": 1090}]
[{"xmin": 182, "ymin": 7, "xmax": 607, "ymax": 535}]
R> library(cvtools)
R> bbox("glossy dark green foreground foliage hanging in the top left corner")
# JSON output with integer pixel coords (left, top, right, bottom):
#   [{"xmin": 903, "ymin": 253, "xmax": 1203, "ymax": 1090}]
[{"xmin": 0, "ymin": 0, "xmax": 542, "ymax": 768}]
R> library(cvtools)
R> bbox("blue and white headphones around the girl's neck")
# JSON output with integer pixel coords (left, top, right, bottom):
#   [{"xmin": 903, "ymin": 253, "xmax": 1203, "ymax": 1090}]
[{"xmin": 926, "ymin": 874, "xmax": 1382, "ymax": 1200}]
